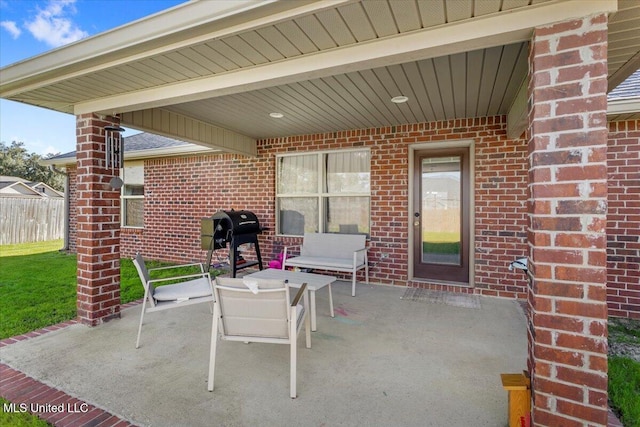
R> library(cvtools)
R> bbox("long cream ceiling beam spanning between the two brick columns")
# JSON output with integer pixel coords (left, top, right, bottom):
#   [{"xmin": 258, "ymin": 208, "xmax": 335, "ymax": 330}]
[{"xmin": 74, "ymin": 0, "xmax": 617, "ymax": 114}]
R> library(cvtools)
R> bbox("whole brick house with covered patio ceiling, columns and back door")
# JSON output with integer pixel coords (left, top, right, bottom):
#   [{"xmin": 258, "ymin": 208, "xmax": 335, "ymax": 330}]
[{"xmin": 5, "ymin": 0, "xmax": 640, "ymax": 426}]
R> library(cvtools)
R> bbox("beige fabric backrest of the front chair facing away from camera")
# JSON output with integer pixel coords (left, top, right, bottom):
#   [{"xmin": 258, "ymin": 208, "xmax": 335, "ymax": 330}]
[{"xmin": 214, "ymin": 277, "xmax": 291, "ymax": 340}]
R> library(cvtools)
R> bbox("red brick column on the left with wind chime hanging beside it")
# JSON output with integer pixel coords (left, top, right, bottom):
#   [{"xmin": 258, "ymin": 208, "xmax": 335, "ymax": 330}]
[{"xmin": 76, "ymin": 114, "xmax": 120, "ymax": 326}]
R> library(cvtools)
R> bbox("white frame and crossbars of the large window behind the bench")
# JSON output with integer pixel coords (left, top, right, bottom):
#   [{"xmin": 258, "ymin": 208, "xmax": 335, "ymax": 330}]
[{"xmin": 275, "ymin": 148, "xmax": 371, "ymax": 237}]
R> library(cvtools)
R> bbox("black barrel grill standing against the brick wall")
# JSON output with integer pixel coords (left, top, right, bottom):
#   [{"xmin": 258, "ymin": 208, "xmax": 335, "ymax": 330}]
[{"xmin": 201, "ymin": 210, "xmax": 262, "ymax": 277}]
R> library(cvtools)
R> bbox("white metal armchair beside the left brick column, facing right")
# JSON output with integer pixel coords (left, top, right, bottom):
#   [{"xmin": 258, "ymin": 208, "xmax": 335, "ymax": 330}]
[{"xmin": 133, "ymin": 253, "xmax": 213, "ymax": 348}]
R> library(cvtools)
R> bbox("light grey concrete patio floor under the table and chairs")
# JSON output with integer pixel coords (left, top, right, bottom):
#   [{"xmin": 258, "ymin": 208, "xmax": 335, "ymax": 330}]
[{"xmin": 0, "ymin": 282, "xmax": 527, "ymax": 427}]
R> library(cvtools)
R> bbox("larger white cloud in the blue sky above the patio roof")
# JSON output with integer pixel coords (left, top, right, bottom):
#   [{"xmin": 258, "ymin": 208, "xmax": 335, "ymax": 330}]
[{"xmin": 25, "ymin": 0, "xmax": 89, "ymax": 47}]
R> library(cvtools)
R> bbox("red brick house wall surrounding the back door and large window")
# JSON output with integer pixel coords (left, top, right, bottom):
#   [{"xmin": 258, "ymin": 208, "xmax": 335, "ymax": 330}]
[{"xmin": 69, "ymin": 117, "xmax": 640, "ymax": 318}]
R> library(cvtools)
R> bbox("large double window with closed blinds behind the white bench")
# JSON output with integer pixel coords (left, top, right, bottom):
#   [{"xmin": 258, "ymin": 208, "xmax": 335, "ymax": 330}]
[{"xmin": 276, "ymin": 150, "xmax": 371, "ymax": 236}]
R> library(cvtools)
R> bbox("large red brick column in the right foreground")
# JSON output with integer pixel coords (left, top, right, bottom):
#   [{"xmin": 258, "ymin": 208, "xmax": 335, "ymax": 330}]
[{"xmin": 528, "ymin": 15, "xmax": 607, "ymax": 426}]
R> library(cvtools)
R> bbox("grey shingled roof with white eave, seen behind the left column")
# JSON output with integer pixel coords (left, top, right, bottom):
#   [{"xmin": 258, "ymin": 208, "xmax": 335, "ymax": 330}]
[{"xmin": 40, "ymin": 132, "xmax": 218, "ymax": 166}]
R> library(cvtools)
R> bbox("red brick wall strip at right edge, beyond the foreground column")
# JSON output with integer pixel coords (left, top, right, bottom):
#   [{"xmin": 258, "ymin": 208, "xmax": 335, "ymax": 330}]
[{"xmin": 607, "ymin": 120, "xmax": 640, "ymax": 319}]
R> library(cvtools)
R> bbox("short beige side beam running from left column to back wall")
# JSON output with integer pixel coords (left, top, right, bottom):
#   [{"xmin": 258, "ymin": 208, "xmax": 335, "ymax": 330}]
[{"xmin": 120, "ymin": 108, "xmax": 258, "ymax": 157}]
